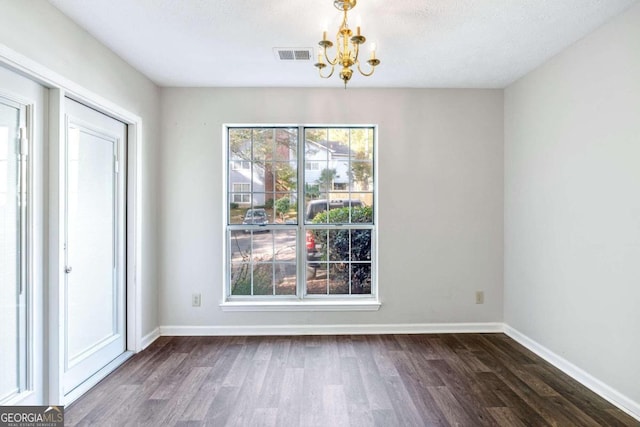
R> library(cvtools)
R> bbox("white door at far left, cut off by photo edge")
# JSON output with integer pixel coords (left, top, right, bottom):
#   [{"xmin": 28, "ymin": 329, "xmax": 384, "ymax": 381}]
[{"xmin": 0, "ymin": 66, "xmax": 47, "ymax": 405}]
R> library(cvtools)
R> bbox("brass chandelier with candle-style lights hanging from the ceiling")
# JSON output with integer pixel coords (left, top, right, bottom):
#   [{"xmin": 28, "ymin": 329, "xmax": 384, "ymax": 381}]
[{"xmin": 314, "ymin": 0, "xmax": 380, "ymax": 89}]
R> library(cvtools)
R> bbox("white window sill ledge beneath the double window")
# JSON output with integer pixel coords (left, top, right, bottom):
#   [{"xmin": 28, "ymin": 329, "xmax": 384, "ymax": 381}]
[{"xmin": 220, "ymin": 300, "xmax": 381, "ymax": 311}]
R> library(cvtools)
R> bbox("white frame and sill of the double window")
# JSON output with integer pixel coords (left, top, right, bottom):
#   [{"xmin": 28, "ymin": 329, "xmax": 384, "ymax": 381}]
[{"xmin": 220, "ymin": 124, "xmax": 381, "ymax": 311}]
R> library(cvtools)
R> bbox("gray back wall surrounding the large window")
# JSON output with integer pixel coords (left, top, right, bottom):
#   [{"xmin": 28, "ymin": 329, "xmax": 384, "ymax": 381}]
[{"xmin": 159, "ymin": 88, "xmax": 503, "ymax": 326}]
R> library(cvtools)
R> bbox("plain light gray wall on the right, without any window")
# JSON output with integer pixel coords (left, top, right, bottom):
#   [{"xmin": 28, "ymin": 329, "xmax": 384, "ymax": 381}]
[{"xmin": 504, "ymin": 6, "xmax": 640, "ymax": 410}]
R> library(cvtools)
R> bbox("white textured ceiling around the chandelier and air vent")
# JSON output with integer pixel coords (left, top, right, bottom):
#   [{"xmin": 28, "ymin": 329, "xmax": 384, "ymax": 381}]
[{"xmin": 49, "ymin": 0, "xmax": 639, "ymax": 88}]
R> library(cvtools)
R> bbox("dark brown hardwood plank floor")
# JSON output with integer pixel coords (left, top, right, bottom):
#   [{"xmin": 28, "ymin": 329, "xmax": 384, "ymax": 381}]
[{"xmin": 65, "ymin": 334, "xmax": 640, "ymax": 427}]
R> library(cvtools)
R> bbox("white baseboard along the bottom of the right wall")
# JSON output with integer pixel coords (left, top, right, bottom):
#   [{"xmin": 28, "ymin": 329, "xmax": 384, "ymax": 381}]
[{"xmin": 504, "ymin": 325, "xmax": 640, "ymax": 421}]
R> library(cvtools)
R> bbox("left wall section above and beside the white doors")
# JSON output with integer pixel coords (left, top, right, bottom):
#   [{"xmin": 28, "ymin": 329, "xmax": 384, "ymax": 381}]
[{"xmin": 0, "ymin": 0, "xmax": 160, "ymax": 335}]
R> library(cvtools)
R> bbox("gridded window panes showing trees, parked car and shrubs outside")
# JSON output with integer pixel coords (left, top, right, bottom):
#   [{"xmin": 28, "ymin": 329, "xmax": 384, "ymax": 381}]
[{"xmin": 227, "ymin": 127, "xmax": 375, "ymax": 299}]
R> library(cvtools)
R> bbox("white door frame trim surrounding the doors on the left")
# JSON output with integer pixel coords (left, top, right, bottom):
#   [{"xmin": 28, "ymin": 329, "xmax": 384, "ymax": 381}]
[{"xmin": 0, "ymin": 44, "xmax": 144, "ymax": 405}]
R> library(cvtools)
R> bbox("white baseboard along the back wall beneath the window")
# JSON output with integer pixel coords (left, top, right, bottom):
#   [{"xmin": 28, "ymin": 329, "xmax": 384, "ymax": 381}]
[{"xmin": 160, "ymin": 323, "xmax": 504, "ymax": 336}]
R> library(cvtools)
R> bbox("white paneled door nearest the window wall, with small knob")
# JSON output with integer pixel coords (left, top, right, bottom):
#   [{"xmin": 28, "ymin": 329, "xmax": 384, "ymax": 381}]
[{"xmin": 63, "ymin": 98, "xmax": 127, "ymax": 395}]
